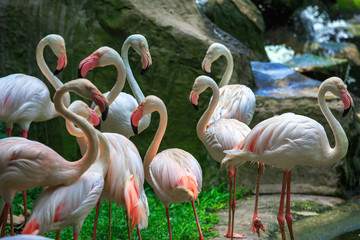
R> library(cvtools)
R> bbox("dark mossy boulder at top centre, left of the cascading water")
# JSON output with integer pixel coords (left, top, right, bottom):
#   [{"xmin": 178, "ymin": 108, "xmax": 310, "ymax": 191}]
[{"xmin": 202, "ymin": 0, "xmax": 268, "ymax": 61}]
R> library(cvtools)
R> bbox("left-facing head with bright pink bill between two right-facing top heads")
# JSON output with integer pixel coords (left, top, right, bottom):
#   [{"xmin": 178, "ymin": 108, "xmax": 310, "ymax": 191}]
[{"xmin": 78, "ymin": 47, "xmax": 121, "ymax": 78}]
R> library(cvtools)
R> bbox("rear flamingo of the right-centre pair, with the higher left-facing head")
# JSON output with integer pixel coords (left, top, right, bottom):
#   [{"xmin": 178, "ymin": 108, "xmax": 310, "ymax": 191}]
[{"xmin": 201, "ymin": 43, "xmax": 258, "ymax": 238}]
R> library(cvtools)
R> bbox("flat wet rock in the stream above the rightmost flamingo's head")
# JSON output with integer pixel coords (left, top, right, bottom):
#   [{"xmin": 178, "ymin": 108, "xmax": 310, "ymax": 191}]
[{"xmin": 284, "ymin": 54, "xmax": 349, "ymax": 81}]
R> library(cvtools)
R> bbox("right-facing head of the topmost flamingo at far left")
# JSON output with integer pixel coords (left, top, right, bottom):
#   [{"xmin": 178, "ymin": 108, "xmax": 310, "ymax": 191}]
[{"xmin": 44, "ymin": 34, "xmax": 67, "ymax": 75}]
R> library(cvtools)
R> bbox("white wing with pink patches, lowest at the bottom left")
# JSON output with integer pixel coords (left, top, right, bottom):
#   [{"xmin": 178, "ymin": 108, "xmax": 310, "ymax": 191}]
[{"xmin": 23, "ymin": 171, "xmax": 104, "ymax": 234}]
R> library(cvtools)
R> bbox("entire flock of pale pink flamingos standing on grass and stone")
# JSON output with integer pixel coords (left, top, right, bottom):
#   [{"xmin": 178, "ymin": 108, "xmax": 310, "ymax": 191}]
[{"xmin": 0, "ymin": 34, "xmax": 353, "ymax": 239}]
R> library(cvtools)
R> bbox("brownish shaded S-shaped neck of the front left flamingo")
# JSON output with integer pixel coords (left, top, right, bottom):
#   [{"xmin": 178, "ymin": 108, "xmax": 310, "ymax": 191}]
[{"xmin": 54, "ymin": 86, "xmax": 99, "ymax": 181}]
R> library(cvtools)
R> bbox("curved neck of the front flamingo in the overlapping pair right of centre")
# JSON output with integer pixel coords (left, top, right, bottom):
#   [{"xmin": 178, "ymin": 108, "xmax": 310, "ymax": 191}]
[{"xmin": 196, "ymin": 81, "xmax": 219, "ymax": 142}]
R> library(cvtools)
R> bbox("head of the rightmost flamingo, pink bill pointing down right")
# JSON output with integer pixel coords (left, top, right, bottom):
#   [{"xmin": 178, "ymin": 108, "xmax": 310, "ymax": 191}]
[{"xmin": 322, "ymin": 77, "xmax": 354, "ymax": 117}]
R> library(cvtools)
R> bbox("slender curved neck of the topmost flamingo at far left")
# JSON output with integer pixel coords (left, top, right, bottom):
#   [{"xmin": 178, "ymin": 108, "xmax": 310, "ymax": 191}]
[{"xmin": 36, "ymin": 38, "xmax": 70, "ymax": 106}]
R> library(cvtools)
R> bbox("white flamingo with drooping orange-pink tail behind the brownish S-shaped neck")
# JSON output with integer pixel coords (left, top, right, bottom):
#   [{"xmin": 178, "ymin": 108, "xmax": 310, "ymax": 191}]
[{"xmin": 66, "ymin": 113, "xmax": 149, "ymax": 239}]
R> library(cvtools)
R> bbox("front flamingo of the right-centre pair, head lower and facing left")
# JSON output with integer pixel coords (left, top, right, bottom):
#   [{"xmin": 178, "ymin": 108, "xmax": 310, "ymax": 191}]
[{"xmin": 189, "ymin": 76, "xmax": 251, "ymax": 238}]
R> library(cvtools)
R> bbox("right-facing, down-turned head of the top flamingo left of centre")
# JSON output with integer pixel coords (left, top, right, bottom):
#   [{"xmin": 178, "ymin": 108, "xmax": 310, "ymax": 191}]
[{"xmin": 126, "ymin": 34, "xmax": 152, "ymax": 75}]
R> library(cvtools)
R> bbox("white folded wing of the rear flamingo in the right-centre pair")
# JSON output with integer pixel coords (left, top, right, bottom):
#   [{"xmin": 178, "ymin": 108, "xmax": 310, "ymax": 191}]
[{"xmin": 209, "ymin": 84, "xmax": 256, "ymax": 125}]
